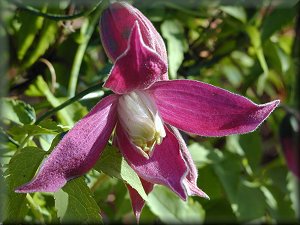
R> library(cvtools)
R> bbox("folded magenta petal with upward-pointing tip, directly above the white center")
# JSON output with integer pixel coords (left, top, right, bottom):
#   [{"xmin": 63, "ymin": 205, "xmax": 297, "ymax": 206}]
[{"xmin": 104, "ymin": 22, "xmax": 167, "ymax": 94}]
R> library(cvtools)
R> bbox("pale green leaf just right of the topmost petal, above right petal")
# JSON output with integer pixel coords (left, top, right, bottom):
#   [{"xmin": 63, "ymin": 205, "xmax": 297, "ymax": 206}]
[{"xmin": 161, "ymin": 19, "xmax": 188, "ymax": 79}]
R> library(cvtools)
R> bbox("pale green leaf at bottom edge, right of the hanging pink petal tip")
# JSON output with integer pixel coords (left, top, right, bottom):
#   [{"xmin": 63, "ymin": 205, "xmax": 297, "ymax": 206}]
[{"xmin": 147, "ymin": 185, "xmax": 205, "ymax": 224}]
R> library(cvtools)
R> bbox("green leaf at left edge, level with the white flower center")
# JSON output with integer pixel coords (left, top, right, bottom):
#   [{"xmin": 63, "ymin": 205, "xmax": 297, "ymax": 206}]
[{"xmin": 0, "ymin": 98, "xmax": 36, "ymax": 125}]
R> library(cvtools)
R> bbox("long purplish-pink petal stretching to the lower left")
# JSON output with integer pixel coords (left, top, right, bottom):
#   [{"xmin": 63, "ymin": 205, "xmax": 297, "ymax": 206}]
[{"xmin": 16, "ymin": 95, "xmax": 118, "ymax": 193}]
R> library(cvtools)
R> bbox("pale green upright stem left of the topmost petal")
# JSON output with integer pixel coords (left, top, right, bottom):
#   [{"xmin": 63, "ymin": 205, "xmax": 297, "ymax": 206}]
[{"xmin": 68, "ymin": 1, "xmax": 107, "ymax": 97}]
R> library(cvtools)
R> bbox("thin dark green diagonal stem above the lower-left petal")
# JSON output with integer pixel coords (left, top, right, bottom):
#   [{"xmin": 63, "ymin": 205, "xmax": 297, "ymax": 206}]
[{"xmin": 35, "ymin": 84, "xmax": 108, "ymax": 125}]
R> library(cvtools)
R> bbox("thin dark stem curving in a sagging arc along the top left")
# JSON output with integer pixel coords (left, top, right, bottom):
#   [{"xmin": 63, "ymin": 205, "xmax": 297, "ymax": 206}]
[{"xmin": 10, "ymin": 1, "xmax": 102, "ymax": 21}]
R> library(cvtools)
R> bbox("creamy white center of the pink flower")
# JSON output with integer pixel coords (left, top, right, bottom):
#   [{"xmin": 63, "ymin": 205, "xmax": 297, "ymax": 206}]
[{"xmin": 118, "ymin": 91, "xmax": 166, "ymax": 158}]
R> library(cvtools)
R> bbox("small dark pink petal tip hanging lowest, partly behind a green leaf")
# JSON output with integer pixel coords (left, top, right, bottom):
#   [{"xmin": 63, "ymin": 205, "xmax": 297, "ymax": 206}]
[{"xmin": 126, "ymin": 178, "xmax": 154, "ymax": 223}]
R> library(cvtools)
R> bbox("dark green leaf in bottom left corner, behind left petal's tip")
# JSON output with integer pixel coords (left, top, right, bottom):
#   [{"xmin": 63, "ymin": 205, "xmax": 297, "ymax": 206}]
[{"xmin": 5, "ymin": 147, "xmax": 46, "ymax": 223}]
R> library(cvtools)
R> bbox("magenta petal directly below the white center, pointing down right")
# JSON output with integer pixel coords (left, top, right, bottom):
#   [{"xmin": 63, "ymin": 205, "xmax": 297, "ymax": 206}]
[{"xmin": 116, "ymin": 124, "xmax": 187, "ymax": 200}]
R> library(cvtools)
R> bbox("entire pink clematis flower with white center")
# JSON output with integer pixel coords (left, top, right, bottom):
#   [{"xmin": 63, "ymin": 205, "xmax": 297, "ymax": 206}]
[{"xmin": 16, "ymin": 3, "xmax": 279, "ymax": 220}]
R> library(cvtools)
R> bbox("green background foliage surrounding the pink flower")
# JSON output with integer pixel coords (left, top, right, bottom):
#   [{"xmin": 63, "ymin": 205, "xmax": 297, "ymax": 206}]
[{"xmin": 0, "ymin": 0, "xmax": 300, "ymax": 223}]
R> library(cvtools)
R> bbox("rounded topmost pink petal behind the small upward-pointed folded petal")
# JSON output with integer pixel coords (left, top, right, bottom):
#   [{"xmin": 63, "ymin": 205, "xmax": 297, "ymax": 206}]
[{"xmin": 99, "ymin": 2, "xmax": 168, "ymax": 67}]
